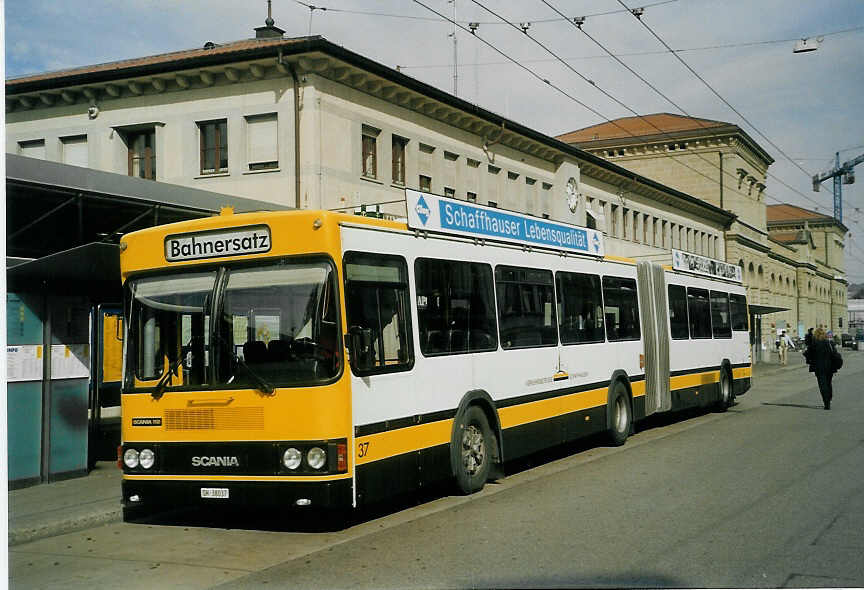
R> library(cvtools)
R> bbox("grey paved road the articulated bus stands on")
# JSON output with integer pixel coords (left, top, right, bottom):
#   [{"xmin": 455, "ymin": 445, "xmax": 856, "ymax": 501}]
[{"xmin": 10, "ymin": 352, "xmax": 864, "ymax": 590}]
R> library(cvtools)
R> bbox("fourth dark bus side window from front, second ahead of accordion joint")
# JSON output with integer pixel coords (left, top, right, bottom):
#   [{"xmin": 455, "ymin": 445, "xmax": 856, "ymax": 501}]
[{"xmin": 555, "ymin": 272, "xmax": 605, "ymax": 344}]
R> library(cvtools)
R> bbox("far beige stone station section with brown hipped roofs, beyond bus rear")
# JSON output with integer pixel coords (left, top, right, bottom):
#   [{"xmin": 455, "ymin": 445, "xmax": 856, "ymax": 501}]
[{"xmin": 558, "ymin": 113, "xmax": 847, "ymax": 358}]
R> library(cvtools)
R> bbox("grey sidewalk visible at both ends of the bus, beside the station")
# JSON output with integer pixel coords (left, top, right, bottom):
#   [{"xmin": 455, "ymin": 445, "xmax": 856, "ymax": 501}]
[{"xmin": 3, "ymin": 351, "xmax": 828, "ymax": 547}]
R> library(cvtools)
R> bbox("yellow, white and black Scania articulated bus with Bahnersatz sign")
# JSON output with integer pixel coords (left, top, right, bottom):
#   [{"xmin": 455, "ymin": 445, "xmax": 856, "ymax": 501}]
[{"xmin": 119, "ymin": 190, "xmax": 751, "ymax": 516}]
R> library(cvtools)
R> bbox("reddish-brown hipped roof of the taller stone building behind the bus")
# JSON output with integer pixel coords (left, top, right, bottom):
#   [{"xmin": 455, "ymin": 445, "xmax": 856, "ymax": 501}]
[{"xmin": 556, "ymin": 113, "xmax": 730, "ymax": 143}]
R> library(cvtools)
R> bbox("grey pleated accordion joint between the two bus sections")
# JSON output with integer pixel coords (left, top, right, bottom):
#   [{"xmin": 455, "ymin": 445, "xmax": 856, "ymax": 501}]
[{"xmin": 636, "ymin": 261, "xmax": 672, "ymax": 416}]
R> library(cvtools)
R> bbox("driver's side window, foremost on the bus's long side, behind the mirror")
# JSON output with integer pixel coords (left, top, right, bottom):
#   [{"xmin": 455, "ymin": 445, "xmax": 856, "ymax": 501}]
[{"xmin": 345, "ymin": 252, "xmax": 414, "ymax": 375}]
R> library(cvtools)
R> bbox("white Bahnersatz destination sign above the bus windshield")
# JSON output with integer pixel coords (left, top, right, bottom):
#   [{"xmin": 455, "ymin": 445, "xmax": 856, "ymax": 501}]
[{"xmin": 165, "ymin": 225, "xmax": 271, "ymax": 262}]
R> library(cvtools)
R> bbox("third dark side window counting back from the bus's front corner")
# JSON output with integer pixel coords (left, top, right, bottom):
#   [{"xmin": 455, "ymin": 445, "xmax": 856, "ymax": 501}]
[{"xmin": 495, "ymin": 266, "xmax": 558, "ymax": 349}]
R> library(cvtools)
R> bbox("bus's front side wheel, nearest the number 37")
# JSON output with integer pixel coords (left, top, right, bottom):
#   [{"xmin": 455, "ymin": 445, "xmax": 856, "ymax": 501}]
[{"xmin": 450, "ymin": 405, "xmax": 495, "ymax": 495}]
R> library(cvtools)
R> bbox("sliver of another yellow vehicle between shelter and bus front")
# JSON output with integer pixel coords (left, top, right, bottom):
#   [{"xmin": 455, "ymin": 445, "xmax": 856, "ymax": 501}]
[{"xmin": 89, "ymin": 304, "xmax": 123, "ymax": 467}]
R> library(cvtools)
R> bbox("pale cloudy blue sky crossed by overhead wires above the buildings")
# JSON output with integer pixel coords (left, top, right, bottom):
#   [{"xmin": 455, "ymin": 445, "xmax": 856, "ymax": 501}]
[{"xmin": 4, "ymin": 0, "xmax": 864, "ymax": 283}]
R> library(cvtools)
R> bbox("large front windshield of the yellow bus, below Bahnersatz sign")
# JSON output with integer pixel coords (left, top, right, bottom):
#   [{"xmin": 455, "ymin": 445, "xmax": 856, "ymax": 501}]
[{"xmin": 125, "ymin": 261, "xmax": 340, "ymax": 395}]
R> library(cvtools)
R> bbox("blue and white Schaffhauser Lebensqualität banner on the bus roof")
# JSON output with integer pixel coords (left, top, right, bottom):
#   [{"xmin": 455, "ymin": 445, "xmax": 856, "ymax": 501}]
[{"xmin": 405, "ymin": 189, "xmax": 605, "ymax": 256}]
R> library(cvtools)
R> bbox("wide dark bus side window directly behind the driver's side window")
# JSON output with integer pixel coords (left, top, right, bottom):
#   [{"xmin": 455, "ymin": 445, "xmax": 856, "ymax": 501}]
[{"xmin": 414, "ymin": 258, "xmax": 498, "ymax": 356}]
